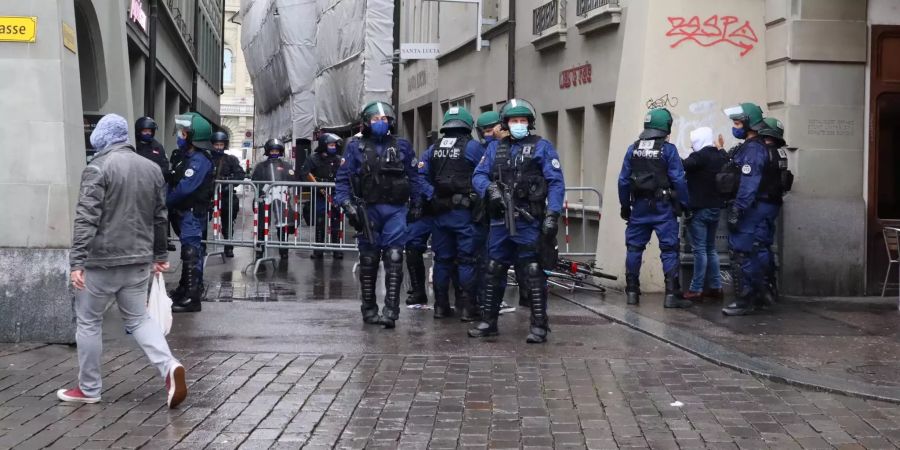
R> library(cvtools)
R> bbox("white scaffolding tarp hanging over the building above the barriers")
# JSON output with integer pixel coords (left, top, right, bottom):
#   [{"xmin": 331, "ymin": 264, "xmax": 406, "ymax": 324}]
[{"xmin": 240, "ymin": 0, "xmax": 394, "ymax": 145}]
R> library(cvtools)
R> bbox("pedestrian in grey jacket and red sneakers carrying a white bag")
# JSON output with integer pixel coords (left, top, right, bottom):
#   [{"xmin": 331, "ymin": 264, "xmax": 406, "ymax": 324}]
[{"xmin": 56, "ymin": 114, "xmax": 187, "ymax": 408}]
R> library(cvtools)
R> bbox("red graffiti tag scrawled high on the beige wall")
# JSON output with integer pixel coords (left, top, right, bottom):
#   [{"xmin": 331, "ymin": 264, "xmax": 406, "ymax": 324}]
[{"xmin": 666, "ymin": 15, "xmax": 759, "ymax": 57}]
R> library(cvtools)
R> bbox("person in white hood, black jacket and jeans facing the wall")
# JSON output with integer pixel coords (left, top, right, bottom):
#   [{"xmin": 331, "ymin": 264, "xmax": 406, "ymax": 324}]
[{"xmin": 684, "ymin": 127, "xmax": 728, "ymax": 300}]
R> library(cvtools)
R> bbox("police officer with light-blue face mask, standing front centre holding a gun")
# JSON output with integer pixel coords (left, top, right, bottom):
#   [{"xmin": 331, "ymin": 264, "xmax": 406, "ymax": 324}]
[{"xmin": 469, "ymin": 99, "xmax": 565, "ymax": 343}]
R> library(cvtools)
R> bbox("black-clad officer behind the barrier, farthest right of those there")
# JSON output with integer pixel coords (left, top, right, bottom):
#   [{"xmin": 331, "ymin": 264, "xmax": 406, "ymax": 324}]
[{"xmin": 301, "ymin": 133, "xmax": 344, "ymax": 259}]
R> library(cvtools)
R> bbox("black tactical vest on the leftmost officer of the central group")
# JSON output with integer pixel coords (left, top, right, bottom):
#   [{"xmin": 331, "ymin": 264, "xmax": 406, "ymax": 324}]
[{"xmin": 357, "ymin": 137, "xmax": 412, "ymax": 205}]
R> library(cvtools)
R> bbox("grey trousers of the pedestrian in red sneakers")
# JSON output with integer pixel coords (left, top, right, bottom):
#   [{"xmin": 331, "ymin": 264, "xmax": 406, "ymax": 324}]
[{"xmin": 74, "ymin": 264, "xmax": 178, "ymax": 397}]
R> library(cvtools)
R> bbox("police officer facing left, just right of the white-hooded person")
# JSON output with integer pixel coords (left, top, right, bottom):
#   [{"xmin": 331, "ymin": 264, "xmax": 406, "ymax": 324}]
[{"xmin": 722, "ymin": 103, "xmax": 780, "ymax": 316}]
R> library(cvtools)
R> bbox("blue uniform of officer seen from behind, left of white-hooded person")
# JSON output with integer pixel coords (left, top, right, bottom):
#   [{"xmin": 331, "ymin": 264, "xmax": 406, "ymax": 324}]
[{"xmin": 619, "ymin": 139, "xmax": 688, "ymax": 277}]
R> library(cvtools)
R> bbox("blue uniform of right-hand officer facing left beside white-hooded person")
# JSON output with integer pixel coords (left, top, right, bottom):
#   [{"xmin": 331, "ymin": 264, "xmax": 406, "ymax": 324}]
[{"xmin": 728, "ymin": 138, "xmax": 780, "ymax": 310}]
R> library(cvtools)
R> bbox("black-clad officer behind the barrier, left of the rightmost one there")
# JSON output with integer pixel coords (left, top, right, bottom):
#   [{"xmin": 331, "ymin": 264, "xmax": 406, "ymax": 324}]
[{"xmin": 250, "ymin": 138, "xmax": 296, "ymax": 259}]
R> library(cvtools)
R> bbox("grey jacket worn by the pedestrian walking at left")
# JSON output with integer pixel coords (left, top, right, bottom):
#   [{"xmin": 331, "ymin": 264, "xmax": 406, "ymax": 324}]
[{"xmin": 69, "ymin": 142, "xmax": 168, "ymax": 270}]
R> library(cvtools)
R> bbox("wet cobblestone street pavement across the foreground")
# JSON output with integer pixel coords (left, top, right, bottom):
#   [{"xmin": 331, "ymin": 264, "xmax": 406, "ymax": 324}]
[{"xmin": 0, "ymin": 252, "xmax": 900, "ymax": 449}]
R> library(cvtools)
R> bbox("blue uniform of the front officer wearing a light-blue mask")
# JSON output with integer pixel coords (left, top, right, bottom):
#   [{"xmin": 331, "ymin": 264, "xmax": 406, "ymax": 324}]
[{"xmin": 469, "ymin": 135, "xmax": 565, "ymax": 342}]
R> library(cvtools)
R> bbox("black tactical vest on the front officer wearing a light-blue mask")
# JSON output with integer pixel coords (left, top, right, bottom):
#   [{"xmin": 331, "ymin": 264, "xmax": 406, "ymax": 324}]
[{"xmin": 491, "ymin": 135, "xmax": 547, "ymax": 217}]
